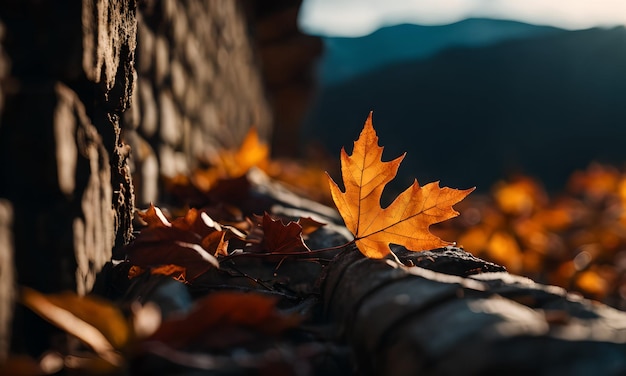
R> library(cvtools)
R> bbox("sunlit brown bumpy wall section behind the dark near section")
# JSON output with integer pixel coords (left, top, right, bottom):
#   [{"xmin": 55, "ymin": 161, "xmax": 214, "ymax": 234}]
[{"xmin": 123, "ymin": 0, "xmax": 271, "ymax": 205}]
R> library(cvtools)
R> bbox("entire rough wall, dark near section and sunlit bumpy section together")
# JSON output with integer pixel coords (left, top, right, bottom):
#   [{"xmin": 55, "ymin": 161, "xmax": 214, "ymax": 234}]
[{"xmin": 0, "ymin": 0, "xmax": 314, "ymax": 362}]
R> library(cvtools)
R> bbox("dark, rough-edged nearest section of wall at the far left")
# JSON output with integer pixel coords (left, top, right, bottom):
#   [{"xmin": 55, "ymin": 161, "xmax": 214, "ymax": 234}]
[{"xmin": 0, "ymin": 0, "xmax": 136, "ymax": 358}]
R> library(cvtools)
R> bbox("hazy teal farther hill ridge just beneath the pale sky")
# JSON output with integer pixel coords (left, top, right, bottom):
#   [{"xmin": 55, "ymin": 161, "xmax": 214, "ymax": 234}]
[{"xmin": 319, "ymin": 19, "xmax": 564, "ymax": 86}]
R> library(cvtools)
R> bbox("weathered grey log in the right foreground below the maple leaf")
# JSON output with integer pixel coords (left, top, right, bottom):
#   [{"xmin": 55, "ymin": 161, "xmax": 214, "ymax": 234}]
[{"xmin": 323, "ymin": 248, "xmax": 626, "ymax": 375}]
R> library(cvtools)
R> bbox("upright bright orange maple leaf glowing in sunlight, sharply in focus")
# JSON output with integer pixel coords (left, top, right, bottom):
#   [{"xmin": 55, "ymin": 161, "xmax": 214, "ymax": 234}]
[{"xmin": 328, "ymin": 112, "xmax": 474, "ymax": 258}]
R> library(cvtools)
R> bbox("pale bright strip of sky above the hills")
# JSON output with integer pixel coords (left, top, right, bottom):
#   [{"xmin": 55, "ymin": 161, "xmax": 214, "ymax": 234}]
[{"xmin": 299, "ymin": 0, "xmax": 626, "ymax": 37}]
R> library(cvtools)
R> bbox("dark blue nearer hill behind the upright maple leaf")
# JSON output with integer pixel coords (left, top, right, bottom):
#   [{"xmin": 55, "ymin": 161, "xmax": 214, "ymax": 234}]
[{"xmin": 303, "ymin": 27, "xmax": 626, "ymax": 194}]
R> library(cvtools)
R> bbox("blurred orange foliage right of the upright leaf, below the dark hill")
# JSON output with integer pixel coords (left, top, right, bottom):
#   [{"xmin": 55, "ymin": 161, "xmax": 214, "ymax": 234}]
[{"xmin": 438, "ymin": 163, "xmax": 626, "ymax": 309}]
